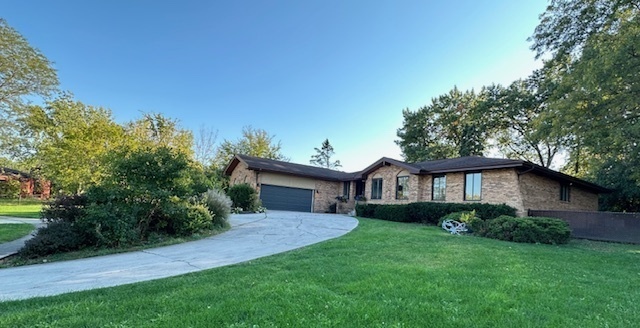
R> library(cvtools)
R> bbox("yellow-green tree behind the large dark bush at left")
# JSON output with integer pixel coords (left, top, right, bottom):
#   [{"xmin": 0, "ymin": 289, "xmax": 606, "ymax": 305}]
[{"xmin": 19, "ymin": 98, "xmax": 125, "ymax": 193}]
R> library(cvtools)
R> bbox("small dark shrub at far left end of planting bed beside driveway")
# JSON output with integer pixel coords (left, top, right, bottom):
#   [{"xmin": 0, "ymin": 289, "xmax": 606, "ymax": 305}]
[{"xmin": 18, "ymin": 221, "xmax": 84, "ymax": 259}]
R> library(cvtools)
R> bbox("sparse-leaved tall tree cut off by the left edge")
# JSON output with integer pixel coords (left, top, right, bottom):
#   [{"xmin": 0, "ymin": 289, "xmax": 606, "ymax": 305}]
[{"xmin": 0, "ymin": 18, "xmax": 58, "ymax": 159}]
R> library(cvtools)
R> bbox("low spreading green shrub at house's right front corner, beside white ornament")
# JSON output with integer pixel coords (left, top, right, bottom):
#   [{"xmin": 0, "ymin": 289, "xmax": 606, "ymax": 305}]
[{"xmin": 474, "ymin": 215, "xmax": 571, "ymax": 244}]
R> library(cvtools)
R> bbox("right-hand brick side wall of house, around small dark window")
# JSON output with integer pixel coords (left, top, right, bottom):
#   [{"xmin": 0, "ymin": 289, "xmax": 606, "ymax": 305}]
[{"xmin": 520, "ymin": 173, "xmax": 598, "ymax": 211}]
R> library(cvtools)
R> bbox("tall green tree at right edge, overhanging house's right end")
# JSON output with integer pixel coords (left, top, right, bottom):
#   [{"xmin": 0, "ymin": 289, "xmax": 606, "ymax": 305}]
[{"xmin": 532, "ymin": 0, "xmax": 640, "ymax": 210}]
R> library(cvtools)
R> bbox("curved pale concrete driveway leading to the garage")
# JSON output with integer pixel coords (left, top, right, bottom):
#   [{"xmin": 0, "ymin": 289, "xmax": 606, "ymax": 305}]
[{"xmin": 0, "ymin": 211, "xmax": 358, "ymax": 301}]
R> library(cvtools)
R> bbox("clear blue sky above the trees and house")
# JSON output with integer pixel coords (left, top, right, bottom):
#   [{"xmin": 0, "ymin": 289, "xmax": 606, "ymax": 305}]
[{"xmin": 0, "ymin": 0, "xmax": 547, "ymax": 171}]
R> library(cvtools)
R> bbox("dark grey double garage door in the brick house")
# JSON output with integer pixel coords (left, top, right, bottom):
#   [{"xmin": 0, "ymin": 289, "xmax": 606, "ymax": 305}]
[{"xmin": 260, "ymin": 184, "xmax": 313, "ymax": 212}]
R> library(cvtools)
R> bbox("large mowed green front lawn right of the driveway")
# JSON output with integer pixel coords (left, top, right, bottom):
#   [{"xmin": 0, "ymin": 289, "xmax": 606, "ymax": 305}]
[{"xmin": 0, "ymin": 219, "xmax": 640, "ymax": 327}]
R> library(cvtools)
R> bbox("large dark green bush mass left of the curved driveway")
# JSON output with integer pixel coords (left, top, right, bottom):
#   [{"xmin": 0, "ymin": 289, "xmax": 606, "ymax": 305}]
[{"xmin": 23, "ymin": 147, "xmax": 218, "ymax": 257}]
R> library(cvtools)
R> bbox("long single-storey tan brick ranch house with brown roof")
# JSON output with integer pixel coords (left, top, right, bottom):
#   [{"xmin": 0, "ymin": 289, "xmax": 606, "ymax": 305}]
[{"xmin": 225, "ymin": 155, "xmax": 610, "ymax": 215}]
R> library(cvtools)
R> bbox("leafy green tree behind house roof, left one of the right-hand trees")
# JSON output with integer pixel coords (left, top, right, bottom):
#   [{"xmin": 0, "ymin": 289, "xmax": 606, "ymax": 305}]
[{"xmin": 396, "ymin": 87, "xmax": 492, "ymax": 162}]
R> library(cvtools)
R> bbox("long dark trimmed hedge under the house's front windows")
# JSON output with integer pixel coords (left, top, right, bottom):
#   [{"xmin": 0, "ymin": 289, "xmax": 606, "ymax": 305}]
[{"xmin": 356, "ymin": 202, "xmax": 516, "ymax": 225}]
